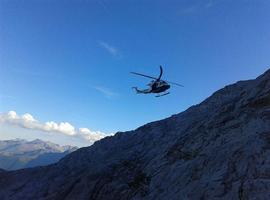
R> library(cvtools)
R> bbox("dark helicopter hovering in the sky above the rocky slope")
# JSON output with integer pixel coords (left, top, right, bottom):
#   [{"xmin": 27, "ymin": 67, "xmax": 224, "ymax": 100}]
[{"xmin": 130, "ymin": 65, "xmax": 184, "ymax": 97}]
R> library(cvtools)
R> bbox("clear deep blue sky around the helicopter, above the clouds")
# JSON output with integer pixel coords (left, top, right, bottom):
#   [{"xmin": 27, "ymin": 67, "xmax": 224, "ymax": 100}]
[{"xmin": 0, "ymin": 0, "xmax": 270, "ymax": 147}]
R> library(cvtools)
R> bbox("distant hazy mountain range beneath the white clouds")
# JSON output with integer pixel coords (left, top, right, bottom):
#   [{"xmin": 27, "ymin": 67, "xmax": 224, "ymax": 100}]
[{"xmin": 0, "ymin": 139, "xmax": 76, "ymax": 170}]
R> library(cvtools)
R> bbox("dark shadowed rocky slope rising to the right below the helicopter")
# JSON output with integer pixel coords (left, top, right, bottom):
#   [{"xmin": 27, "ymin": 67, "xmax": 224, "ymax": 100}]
[{"xmin": 0, "ymin": 70, "xmax": 270, "ymax": 200}]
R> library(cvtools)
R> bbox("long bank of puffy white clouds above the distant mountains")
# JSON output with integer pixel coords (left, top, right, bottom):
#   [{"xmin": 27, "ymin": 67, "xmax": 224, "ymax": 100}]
[{"xmin": 0, "ymin": 111, "xmax": 108, "ymax": 142}]
